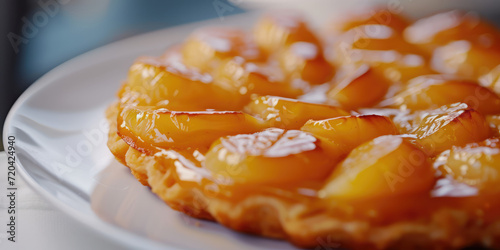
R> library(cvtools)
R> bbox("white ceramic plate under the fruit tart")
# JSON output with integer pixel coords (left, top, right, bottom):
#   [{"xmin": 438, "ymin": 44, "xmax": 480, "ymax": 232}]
[{"xmin": 3, "ymin": 14, "xmax": 294, "ymax": 249}]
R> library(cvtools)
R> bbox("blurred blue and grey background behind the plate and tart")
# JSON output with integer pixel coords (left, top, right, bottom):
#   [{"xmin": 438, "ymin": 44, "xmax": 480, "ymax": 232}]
[{"xmin": 0, "ymin": 0, "xmax": 500, "ymax": 150}]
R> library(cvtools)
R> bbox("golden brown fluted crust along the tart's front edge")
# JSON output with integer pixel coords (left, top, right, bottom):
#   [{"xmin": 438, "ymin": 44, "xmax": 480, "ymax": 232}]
[{"xmin": 107, "ymin": 104, "xmax": 500, "ymax": 249}]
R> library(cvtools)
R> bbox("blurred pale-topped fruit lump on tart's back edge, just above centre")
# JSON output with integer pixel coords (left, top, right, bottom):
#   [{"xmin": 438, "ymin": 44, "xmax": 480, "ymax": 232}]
[{"xmin": 254, "ymin": 11, "xmax": 320, "ymax": 53}]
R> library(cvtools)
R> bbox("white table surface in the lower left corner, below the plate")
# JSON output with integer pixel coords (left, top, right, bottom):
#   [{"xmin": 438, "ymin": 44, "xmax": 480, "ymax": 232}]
[{"xmin": 0, "ymin": 152, "xmax": 125, "ymax": 250}]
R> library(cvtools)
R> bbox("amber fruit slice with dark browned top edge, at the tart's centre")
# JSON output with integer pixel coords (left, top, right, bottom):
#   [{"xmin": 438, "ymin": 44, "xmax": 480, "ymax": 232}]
[{"xmin": 300, "ymin": 115, "xmax": 399, "ymax": 153}]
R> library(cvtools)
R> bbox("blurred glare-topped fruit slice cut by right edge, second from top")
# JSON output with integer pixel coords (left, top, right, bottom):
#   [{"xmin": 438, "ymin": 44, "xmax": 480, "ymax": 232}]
[{"xmin": 431, "ymin": 40, "xmax": 500, "ymax": 79}]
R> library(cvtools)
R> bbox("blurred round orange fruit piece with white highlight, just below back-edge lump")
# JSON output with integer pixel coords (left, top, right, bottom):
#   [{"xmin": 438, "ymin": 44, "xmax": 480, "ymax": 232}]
[{"xmin": 279, "ymin": 42, "xmax": 333, "ymax": 84}]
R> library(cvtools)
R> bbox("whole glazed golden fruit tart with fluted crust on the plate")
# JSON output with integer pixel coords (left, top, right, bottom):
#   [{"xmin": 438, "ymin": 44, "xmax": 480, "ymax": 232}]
[{"xmin": 107, "ymin": 8, "xmax": 500, "ymax": 249}]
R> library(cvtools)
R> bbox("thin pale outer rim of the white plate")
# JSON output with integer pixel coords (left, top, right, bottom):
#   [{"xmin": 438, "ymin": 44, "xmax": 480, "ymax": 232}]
[{"xmin": 2, "ymin": 11, "xmax": 258, "ymax": 250}]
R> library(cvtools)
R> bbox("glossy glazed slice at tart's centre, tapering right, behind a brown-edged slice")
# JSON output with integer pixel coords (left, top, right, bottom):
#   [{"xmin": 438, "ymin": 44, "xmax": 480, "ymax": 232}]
[{"xmin": 245, "ymin": 96, "xmax": 349, "ymax": 129}]
